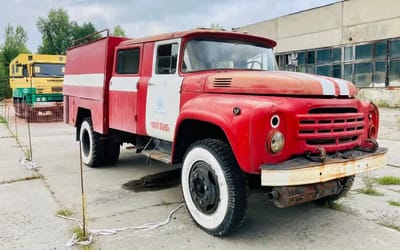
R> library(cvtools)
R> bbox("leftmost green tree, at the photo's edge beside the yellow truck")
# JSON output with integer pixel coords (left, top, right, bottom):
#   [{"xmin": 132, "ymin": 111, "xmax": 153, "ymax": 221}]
[{"xmin": 0, "ymin": 24, "xmax": 29, "ymax": 99}]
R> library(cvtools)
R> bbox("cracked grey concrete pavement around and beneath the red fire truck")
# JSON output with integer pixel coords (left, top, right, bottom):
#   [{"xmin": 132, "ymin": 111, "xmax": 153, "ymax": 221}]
[{"xmin": 0, "ymin": 109, "xmax": 400, "ymax": 249}]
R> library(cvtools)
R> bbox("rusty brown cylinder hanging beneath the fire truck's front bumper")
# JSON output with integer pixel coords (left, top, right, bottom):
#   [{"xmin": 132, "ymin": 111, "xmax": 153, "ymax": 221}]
[{"xmin": 267, "ymin": 180, "xmax": 343, "ymax": 208}]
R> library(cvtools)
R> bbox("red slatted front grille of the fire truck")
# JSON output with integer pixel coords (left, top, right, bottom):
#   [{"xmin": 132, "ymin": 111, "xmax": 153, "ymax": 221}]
[{"xmin": 296, "ymin": 108, "xmax": 364, "ymax": 146}]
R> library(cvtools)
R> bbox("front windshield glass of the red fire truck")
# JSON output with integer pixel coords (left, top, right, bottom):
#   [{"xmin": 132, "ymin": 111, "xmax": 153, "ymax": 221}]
[{"xmin": 182, "ymin": 39, "xmax": 276, "ymax": 72}]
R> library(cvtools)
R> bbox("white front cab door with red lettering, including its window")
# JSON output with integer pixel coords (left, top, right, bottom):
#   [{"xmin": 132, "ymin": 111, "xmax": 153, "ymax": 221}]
[{"xmin": 146, "ymin": 39, "xmax": 183, "ymax": 141}]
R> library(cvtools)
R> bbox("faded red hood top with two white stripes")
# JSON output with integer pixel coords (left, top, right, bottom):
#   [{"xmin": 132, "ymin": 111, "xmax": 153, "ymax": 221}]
[{"xmin": 205, "ymin": 71, "xmax": 357, "ymax": 97}]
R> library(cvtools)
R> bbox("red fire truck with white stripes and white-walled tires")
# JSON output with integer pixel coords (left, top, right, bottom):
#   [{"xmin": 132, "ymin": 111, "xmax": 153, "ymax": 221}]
[{"xmin": 64, "ymin": 29, "xmax": 386, "ymax": 235}]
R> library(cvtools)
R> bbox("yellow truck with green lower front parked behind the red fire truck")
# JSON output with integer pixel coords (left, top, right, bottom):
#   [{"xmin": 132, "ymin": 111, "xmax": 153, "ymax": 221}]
[{"xmin": 10, "ymin": 54, "xmax": 66, "ymax": 121}]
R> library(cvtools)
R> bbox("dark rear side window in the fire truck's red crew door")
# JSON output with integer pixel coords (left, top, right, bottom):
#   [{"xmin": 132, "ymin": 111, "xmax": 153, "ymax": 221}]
[{"xmin": 116, "ymin": 48, "xmax": 140, "ymax": 74}]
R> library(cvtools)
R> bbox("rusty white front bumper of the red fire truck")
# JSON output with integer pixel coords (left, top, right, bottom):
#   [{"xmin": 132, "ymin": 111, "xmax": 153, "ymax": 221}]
[{"xmin": 261, "ymin": 148, "xmax": 387, "ymax": 186}]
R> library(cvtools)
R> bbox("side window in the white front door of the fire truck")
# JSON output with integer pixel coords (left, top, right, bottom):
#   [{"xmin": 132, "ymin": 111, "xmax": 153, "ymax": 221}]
[{"xmin": 156, "ymin": 43, "xmax": 178, "ymax": 75}]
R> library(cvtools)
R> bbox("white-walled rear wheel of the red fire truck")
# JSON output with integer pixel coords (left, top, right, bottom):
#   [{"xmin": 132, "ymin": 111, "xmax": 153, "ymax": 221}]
[{"xmin": 79, "ymin": 118, "xmax": 104, "ymax": 167}]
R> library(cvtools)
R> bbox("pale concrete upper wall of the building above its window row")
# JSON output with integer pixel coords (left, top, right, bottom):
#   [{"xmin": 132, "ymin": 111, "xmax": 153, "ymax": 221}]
[{"xmin": 237, "ymin": 0, "xmax": 400, "ymax": 53}]
